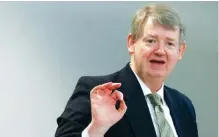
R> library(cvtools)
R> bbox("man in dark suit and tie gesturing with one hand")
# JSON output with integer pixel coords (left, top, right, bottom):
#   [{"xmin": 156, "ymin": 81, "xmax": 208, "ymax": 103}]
[{"xmin": 55, "ymin": 4, "xmax": 198, "ymax": 137}]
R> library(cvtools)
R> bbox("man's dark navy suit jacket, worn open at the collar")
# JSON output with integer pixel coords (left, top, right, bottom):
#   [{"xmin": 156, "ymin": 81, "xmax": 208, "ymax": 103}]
[{"xmin": 55, "ymin": 64, "xmax": 198, "ymax": 137}]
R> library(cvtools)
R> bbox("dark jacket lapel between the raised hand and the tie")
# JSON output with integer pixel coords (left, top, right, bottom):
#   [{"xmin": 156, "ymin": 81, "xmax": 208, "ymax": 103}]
[{"xmin": 117, "ymin": 64, "xmax": 156, "ymax": 137}]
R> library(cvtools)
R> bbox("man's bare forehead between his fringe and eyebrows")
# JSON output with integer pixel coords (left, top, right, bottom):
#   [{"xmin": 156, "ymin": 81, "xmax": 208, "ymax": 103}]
[{"xmin": 143, "ymin": 17, "xmax": 180, "ymax": 40}]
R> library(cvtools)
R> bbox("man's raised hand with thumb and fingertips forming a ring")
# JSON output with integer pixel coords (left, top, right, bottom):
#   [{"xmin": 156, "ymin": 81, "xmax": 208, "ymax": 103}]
[{"xmin": 88, "ymin": 82, "xmax": 127, "ymax": 137}]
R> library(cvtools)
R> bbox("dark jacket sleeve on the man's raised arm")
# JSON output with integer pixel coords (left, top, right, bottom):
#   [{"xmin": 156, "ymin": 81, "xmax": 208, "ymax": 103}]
[{"xmin": 55, "ymin": 77, "xmax": 93, "ymax": 137}]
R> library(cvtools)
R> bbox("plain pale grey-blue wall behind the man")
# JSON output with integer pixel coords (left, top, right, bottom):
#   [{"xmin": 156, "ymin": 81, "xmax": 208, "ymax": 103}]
[{"xmin": 0, "ymin": 2, "xmax": 218, "ymax": 137}]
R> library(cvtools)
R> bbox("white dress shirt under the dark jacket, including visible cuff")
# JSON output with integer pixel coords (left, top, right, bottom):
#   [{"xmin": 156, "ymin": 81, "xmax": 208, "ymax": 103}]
[{"xmin": 82, "ymin": 71, "xmax": 178, "ymax": 137}]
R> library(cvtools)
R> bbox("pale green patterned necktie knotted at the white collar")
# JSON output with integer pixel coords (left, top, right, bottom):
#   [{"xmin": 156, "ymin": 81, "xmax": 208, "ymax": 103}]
[{"xmin": 147, "ymin": 93, "xmax": 175, "ymax": 137}]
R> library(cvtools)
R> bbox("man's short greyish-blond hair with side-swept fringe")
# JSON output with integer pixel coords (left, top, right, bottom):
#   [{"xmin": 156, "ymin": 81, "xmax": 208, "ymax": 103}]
[{"xmin": 131, "ymin": 4, "xmax": 186, "ymax": 42}]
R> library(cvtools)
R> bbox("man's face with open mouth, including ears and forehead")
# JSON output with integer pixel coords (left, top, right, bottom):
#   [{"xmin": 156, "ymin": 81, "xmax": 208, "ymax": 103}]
[{"xmin": 128, "ymin": 17, "xmax": 185, "ymax": 78}]
